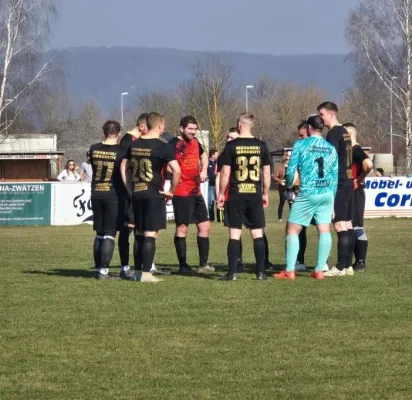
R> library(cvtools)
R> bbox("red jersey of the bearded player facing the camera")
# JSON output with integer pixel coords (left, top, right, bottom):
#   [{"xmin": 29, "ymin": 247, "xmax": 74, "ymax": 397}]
[{"xmin": 169, "ymin": 137, "xmax": 204, "ymax": 196}]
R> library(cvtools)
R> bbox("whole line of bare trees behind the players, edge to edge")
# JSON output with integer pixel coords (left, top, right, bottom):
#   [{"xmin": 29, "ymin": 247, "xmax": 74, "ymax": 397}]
[{"xmin": 0, "ymin": 0, "xmax": 412, "ymax": 171}]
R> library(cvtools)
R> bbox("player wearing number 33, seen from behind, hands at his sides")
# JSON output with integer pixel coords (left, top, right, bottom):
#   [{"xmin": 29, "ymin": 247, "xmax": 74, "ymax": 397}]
[{"xmin": 218, "ymin": 113, "xmax": 271, "ymax": 281}]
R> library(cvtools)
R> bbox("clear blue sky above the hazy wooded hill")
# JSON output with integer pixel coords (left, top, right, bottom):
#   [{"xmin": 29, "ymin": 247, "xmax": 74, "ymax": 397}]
[{"xmin": 52, "ymin": 0, "xmax": 358, "ymax": 55}]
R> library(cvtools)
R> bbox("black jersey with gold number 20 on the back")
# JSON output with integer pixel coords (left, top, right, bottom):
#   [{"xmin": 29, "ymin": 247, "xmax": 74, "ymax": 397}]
[{"xmin": 127, "ymin": 138, "xmax": 175, "ymax": 198}]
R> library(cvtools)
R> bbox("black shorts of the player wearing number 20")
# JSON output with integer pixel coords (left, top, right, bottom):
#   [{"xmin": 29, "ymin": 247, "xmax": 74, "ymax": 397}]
[{"xmin": 132, "ymin": 197, "xmax": 166, "ymax": 233}]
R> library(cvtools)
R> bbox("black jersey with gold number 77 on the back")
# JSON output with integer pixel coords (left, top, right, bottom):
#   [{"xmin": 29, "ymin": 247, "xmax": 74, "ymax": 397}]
[{"xmin": 90, "ymin": 143, "xmax": 125, "ymax": 198}]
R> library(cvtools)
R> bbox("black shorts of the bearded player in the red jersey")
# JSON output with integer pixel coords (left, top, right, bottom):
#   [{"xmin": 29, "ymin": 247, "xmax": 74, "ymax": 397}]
[{"xmin": 172, "ymin": 194, "xmax": 209, "ymax": 226}]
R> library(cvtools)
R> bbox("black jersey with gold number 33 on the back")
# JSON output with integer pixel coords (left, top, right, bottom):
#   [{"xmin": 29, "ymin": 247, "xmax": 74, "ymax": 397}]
[{"xmin": 221, "ymin": 137, "xmax": 271, "ymax": 199}]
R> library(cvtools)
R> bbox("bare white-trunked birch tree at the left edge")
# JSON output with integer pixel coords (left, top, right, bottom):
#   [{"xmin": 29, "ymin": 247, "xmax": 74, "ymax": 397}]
[{"xmin": 0, "ymin": 0, "xmax": 57, "ymax": 137}]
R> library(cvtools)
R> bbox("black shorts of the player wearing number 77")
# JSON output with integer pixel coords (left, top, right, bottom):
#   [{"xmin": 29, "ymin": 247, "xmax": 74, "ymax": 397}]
[{"xmin": 91, "ymin": 197, "xmax": 119, "ymax": 235}]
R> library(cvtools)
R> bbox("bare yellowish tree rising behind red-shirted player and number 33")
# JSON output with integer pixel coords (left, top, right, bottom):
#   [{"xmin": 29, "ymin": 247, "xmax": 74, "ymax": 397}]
[{"xmin": 181, "ymin": 54, "xmax": 239, "ymax": 150}]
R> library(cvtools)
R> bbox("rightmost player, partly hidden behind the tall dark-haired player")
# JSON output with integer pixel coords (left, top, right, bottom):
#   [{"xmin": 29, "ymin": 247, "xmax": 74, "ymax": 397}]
[{"xmin": 343, "ymin": 123, "xmax": 373, "ymax": 272}]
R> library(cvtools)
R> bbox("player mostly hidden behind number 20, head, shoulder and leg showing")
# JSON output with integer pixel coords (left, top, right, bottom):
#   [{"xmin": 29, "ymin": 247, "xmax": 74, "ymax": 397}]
[{"xmin": 118, "ymin": 113, "xmax": 149, "ymax": 277}]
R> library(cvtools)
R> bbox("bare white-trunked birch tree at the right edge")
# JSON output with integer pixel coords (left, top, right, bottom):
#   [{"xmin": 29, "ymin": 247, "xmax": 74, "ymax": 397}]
[{"xmin": 347, "ymin": 0, "xmax": 412, "ymax": 170}]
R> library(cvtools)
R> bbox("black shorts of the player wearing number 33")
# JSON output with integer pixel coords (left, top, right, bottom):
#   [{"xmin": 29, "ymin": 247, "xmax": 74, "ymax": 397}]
[{"xmin": 225, "ymin": 196, "xmax": 265, "ymax": 229}]
